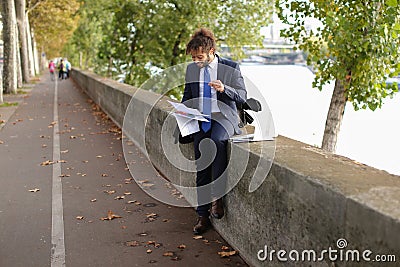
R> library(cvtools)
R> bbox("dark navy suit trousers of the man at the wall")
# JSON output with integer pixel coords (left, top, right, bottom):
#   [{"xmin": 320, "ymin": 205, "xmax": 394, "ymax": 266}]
[{"xmin": 194, "ymin": 113, "xmax": 234, "ymax": 217}]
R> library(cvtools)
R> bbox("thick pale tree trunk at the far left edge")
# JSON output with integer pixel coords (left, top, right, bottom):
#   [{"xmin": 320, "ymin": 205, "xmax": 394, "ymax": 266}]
[{"xmin": 2, "ymin": 0, "xmax": 17, "ymax": 94}]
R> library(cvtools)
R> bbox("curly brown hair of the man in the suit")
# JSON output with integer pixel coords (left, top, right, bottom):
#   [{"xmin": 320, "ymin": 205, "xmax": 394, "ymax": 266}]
[{"xmin": 186, "ymin": 28, "xmax": 217, "ymax": 54}]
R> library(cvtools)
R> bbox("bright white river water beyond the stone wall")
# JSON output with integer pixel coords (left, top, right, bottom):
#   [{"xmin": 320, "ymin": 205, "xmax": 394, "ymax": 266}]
[{"xmin": 241, "ymin": 64, "xmax": 400, "ymax": 178}]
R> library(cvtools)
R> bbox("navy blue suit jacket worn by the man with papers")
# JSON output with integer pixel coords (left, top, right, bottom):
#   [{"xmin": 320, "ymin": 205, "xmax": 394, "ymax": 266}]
[{"xmin": 182, "ymin": 55, "xmax": 247, "ymax": 134}]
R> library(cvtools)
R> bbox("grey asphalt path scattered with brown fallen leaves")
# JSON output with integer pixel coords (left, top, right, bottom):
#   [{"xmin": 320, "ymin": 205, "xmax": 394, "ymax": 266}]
[{"xmin": 0, "ymin": 75, "xmax": 246, "ymax": 267}]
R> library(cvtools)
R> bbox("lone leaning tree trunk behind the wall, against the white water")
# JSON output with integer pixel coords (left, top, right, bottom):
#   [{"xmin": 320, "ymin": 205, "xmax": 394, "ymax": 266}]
[{"xmin": 322, "ymin": 80, "xmax": 347, "ymax": 153}]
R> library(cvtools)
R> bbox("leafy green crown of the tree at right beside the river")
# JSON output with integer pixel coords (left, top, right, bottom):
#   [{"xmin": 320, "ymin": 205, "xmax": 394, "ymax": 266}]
[{"xmin": 276, "ymin": 0, "xmax": 400, "ymax": 110}]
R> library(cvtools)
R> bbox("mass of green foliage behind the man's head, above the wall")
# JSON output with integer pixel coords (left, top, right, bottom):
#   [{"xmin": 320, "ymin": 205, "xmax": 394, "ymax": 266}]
[{"xmin": 65, "ymin": 0, "xmax": 273, "ymax": 96}]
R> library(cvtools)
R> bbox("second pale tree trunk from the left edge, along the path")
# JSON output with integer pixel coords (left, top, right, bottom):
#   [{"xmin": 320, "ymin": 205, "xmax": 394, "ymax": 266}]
[{"xmin": 15, "ymin": 0, "xmax": 30, "ymax": 83}]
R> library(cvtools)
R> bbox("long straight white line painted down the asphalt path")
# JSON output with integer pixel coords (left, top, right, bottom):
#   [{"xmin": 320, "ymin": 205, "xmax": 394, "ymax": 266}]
[{"xmin": 51, "ymin": 77, "xmax": 65, "ymax": 267}]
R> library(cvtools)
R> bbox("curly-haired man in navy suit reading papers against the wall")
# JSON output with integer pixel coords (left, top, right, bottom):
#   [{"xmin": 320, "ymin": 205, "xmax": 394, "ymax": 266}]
[{"xmin": 182, "ymin": 28, "xmax": 247, "ymax": 234}]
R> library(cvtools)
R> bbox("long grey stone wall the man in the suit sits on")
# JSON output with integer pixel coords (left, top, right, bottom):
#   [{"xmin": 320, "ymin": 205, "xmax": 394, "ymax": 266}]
[{"xmin": 72, "ymin": 69, "xmax": 400, "ymax": 266}]
